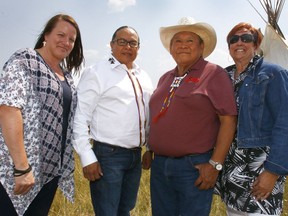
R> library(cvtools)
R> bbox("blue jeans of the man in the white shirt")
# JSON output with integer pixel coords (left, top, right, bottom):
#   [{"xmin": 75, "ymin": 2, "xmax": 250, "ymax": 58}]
[{"xmin": 90, "ymin": 142, "xmax": 142, "ymax": 216}]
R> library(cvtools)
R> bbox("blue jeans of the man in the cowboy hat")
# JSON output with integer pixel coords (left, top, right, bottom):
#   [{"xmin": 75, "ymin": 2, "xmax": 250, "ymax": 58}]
[{"xmin": 151, "ymin": 153, "xmax": 213, "ymax": 216}]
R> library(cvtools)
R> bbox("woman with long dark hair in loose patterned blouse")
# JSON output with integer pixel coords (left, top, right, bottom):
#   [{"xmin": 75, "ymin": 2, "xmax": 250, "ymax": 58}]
[{"xmin": 0, "ymin": 14, "xmax": 84, "ymax": 216}]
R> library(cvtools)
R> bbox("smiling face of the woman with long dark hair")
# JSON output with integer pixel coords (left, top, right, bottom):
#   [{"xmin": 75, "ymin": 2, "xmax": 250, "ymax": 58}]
[{"xmin": 45, "ymin": 20, "xmax": 77, "ymax": 61}]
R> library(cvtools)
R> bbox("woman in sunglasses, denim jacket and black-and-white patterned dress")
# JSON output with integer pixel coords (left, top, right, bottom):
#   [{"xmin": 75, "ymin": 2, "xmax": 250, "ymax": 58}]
[{"xmin": 215, "ymin": 23, "xmax": 288, "ymax": 216}]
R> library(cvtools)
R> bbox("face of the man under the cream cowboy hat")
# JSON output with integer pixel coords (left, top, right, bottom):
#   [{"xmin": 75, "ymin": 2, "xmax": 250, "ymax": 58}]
[{"xmin": 170, "ymin": 32, "xmax": 204, "ymax": 67}]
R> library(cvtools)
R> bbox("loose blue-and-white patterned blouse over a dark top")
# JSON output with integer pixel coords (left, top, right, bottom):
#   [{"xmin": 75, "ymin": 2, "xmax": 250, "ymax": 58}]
[{"xmin": 0, "ymin": 48, "xmax": 77, "ymax": 215}]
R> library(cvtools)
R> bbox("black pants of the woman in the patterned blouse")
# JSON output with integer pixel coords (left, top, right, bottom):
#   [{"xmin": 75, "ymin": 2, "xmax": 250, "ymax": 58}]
[{"xmin": 0, "ymin": 177, "xmax": 59, "ymax": 216}]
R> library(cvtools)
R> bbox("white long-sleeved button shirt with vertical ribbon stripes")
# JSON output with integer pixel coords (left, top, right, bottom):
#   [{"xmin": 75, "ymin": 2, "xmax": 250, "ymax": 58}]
[{"xmin": 74, "ymin": 57, "xmax": 153, "ymax": 167}]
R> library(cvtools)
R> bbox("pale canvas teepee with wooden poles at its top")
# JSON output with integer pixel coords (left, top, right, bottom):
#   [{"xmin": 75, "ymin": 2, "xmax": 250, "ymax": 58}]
[{"xmin": 248, "ymin": 0, "xmax": 288, "ymax": 69}]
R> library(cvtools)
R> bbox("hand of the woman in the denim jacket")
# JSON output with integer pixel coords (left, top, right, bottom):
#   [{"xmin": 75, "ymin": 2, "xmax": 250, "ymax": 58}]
[{"xmin": 252, "ymin": 170, "xmax": 279, "ymax": 200}]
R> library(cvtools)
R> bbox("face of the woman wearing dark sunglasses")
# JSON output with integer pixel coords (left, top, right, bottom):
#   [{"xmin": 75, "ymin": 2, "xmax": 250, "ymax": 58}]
[{"xmin": 229, "ymin": 28, "xmax": 256, "ymax": 64}]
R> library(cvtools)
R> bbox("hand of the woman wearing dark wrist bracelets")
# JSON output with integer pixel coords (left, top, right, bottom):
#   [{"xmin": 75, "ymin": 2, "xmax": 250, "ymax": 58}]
[{"xmin": 14, "ymin": 171, "xmax": 35, "ymax": 195}]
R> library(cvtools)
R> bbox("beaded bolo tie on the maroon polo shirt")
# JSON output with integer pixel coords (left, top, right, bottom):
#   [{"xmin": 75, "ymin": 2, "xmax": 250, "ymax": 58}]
[{"xmin": 152, "ymin": 70, "xmax": 190, "ymax": 123}]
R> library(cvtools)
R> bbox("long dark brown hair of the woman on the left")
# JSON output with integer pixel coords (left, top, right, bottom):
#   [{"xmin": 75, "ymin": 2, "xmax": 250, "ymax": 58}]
[{"xmin": 34, "ymin": 14, "xmax": 84, "ymax": 74}]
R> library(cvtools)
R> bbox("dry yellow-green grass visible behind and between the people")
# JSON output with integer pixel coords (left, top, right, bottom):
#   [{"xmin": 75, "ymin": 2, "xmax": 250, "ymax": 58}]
[{"xmin": 49, "ymin": 155, "xmax": 288, "ymax": 216}]
